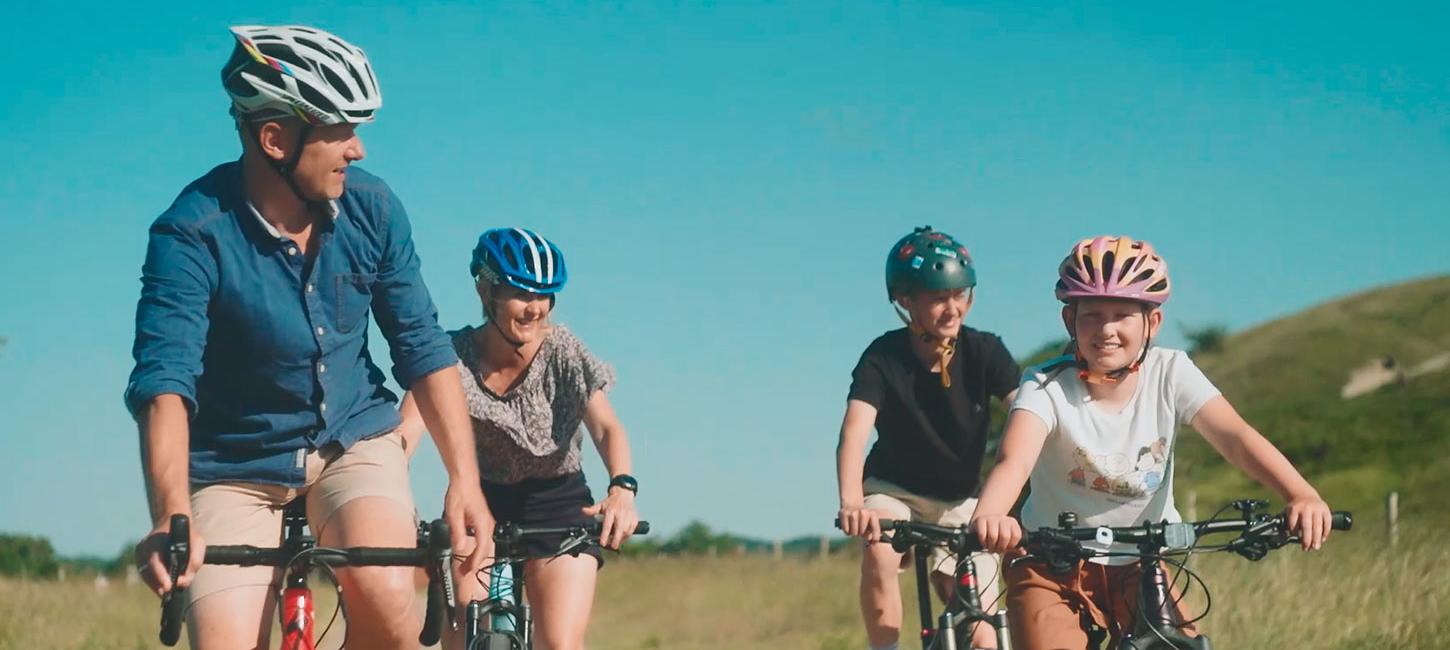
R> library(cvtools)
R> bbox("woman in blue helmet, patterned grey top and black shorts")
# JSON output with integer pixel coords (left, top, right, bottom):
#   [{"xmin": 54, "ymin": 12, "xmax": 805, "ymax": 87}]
[{"xmin": 403, "ymin": 228, "xmax": 639, "ymax": 650}]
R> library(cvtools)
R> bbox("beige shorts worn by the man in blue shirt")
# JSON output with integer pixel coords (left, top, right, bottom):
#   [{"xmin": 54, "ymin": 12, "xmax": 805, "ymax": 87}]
[{"xmin": 189, "ymin": 431, "xmax": 413, "ymax": 602}]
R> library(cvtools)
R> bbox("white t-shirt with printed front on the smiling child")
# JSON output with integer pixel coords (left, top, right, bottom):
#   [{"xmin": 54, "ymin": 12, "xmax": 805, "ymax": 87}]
[{"xmin": 1012, "ymin": 348, "xmax": 1219, "ymax": 564}]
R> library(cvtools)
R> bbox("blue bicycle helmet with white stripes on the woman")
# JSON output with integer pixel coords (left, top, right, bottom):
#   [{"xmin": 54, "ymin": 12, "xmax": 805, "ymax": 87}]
[{"xmin": 468, "ymin": 228, "xmax": 568, "ymax": 295}]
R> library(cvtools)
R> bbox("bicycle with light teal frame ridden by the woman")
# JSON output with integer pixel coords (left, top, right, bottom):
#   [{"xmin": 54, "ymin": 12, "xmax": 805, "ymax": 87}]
[{"xmin": 464, "ymin": 521, "xmax": 650, "ymax": 650}]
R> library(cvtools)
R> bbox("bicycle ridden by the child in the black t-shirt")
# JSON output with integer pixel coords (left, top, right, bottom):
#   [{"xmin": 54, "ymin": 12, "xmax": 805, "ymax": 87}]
[{"xmin": 835, "ymin": 519, "xmax": 1012, "ymax": 650}]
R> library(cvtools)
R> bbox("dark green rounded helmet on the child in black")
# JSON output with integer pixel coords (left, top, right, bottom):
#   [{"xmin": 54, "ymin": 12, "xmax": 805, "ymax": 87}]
[{"xmin": 886, "ymin": 226, "xmax": 977, "ymax": 300}]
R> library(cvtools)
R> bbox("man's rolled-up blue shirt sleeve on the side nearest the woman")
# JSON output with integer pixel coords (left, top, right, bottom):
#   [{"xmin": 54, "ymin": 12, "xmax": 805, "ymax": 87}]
[{"xmin": 373, "ymin": 192, "xmax": 458, "ymax": 390}]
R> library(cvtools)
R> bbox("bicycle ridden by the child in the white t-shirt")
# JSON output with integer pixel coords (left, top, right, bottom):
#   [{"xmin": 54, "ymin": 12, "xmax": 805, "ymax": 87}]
[{"xmin": 1012, "ymin": 499, "xmax": 1354, "ymax": 650}]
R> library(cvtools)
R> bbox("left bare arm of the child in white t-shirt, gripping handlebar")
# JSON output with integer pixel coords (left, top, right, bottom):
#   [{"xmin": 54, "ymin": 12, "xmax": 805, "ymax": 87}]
[{"xmin": 972, "ymin": 409, "xmax": 1047, "ymax": 553}]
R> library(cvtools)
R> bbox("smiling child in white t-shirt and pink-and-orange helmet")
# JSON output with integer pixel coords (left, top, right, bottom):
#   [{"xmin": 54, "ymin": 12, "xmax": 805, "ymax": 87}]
[{"xmin": 973, "ymin": 236, "xmax": 1330, "ymax": 650}]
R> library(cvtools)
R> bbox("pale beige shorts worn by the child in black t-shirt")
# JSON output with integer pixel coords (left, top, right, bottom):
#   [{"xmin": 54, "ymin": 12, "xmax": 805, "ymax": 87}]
[{"xmin": 861, "ymin": 477, "xmax": 1002, "ymax": 609}]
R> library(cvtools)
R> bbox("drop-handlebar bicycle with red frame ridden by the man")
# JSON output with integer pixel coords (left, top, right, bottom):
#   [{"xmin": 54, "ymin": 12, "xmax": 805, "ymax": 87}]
[{"xmin": 161, "ymin": 499, "xmax": 455, "ymax": 650}]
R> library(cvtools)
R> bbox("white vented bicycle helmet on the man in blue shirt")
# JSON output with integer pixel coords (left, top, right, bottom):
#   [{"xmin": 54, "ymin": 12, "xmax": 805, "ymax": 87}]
[{"xmin": 222, "ymin": 25, "xmax": 383, "ymax": 126}]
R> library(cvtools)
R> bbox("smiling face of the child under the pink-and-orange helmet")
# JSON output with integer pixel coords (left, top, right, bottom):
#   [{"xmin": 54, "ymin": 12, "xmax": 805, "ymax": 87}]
[{"xmin": 1063, "ymin": 299, "xmax": 1163, "ymax": 373}]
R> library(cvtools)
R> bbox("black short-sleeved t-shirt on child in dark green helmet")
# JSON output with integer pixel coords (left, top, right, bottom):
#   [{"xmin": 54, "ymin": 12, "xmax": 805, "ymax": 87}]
[{"xmin": 848, "ymin": 326, "xmax": 1019, "ymax": 499}]
